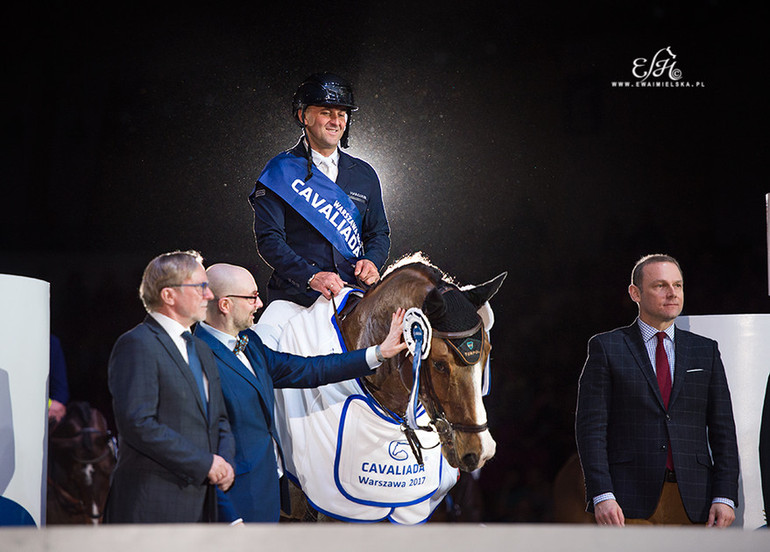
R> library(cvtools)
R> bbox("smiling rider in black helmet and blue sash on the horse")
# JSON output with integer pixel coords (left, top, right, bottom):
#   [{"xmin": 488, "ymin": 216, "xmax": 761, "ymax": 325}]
[{"xmin": 249, "ymin": 73, "xmax": 390, "ymax": 348}]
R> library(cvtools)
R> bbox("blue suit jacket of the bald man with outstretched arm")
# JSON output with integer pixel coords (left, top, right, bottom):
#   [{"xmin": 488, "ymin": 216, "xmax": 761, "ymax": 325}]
[{"xmin": 195, "ymin": 325, "xmax": 371, "ymax": 522}]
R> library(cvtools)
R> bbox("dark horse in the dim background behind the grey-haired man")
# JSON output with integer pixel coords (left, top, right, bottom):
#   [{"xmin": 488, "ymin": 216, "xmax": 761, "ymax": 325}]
[{"xmin": 46, "ymin": 402, "xmax": 117, "ymax": 525}]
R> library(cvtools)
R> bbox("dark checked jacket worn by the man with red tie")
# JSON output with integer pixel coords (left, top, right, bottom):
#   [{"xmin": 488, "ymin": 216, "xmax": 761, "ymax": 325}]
[{"xmin": 576, "ymin": 323, "xmax": 738, "ymax": 523}]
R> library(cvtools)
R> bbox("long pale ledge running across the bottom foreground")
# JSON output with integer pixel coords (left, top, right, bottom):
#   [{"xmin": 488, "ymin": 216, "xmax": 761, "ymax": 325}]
[{"xmin": 0, "ymin": 523, "xmax": 770, "ymax": 552}]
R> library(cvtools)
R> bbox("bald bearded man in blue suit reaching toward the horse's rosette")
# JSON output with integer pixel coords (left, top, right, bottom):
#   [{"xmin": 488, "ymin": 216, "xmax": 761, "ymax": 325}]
[{"xmin": 195, "ymin": 264, "xmax": 406, "ymax": 522}]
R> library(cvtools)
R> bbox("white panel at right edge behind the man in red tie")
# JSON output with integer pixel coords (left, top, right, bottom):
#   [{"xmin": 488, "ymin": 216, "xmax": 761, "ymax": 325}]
[{"xmin": 676, "ymin": 314, "xmax": 770, "ymax": 529}]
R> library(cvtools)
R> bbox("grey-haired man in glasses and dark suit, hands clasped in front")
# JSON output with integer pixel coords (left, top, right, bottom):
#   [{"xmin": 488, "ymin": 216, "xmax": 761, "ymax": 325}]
[{"xmin": 104, "ymin": 251, "xmax": 235, "ymax": 523}]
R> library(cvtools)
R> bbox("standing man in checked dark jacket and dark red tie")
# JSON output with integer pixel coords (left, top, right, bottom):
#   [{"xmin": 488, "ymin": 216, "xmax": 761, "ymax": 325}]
[{"xmin": 575, "ymin": 255, "xmax": 738, "ymax": 527}]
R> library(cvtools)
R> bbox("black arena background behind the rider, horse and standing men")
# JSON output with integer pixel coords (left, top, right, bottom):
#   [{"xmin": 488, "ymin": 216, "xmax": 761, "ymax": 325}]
[{"xmin": 0, "ymin": 0, "xmax": 770, "ymax": 522}]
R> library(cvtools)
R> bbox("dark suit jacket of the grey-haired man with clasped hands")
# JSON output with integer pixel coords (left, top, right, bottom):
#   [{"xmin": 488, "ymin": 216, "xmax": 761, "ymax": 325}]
[{"xmin": 105, "ymin": 316, "xmax": 235, "ymax": 523}]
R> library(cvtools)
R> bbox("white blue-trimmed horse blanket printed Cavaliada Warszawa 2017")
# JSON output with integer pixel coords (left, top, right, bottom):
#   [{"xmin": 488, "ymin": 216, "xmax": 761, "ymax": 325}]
[{"xmin": 275, "ymin": 289, "xmax": 459, "ymax": 525}]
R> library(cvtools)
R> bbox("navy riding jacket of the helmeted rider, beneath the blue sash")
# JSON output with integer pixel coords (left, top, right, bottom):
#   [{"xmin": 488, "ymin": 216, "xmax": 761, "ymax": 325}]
[{"xmin": 249, "ymin": 141, "xmax": 390, "ymax": 307}]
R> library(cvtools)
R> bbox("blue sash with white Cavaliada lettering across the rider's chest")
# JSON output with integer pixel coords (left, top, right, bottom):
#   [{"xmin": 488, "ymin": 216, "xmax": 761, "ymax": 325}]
[{"xmin": 259, "ymin": 153, "xmax": 363, "ymax": 261}]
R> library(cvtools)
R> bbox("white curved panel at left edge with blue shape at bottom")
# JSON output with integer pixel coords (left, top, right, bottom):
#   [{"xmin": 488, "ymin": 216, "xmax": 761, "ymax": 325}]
[{"xmin": 0, "ymin": 274, "xmax": 50, "ymax": 527}]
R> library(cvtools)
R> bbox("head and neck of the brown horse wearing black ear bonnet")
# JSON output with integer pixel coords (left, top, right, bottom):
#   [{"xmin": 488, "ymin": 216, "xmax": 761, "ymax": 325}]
[{"xmin": 279, "ymin": 254, "xmax": 507, "ymax": 523}]
